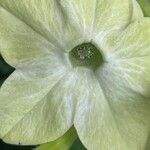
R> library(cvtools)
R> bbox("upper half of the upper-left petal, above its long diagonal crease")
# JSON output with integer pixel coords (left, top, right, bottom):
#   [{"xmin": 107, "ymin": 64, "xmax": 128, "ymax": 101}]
[{"xmin": 0, "ymin": 0, "xmax": 81, "ymax": 48}]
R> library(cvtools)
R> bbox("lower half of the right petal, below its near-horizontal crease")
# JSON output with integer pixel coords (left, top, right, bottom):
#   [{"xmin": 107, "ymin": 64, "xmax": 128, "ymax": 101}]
[{"xmin": 112, "ymin": 56, "xmax": 150, "ymax": 96}]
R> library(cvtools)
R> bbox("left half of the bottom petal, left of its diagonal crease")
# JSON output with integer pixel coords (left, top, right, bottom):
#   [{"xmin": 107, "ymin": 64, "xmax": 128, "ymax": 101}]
[{"xmin": 74, "ymin": 68, "xmax": 127, "ymax": 150}]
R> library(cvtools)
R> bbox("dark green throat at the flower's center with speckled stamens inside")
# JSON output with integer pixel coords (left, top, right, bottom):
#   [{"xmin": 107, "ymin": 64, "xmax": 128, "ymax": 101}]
[{"xmin": 69, "ymin": 43, "xmax": 104, "ymax": 70}]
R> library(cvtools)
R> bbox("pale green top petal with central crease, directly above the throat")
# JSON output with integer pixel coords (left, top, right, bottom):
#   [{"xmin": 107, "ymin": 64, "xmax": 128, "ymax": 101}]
[{"xmin": 61, "ymin": 0, "xmax": 137, "ymax": 40}]
